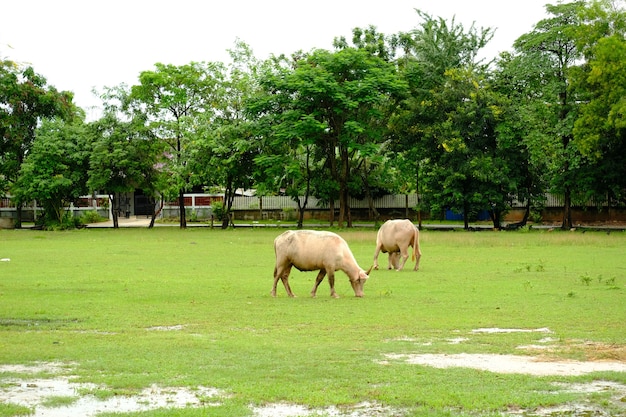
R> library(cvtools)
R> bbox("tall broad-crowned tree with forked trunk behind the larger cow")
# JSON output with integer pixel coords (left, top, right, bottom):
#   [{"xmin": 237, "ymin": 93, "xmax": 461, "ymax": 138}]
[{"xmin": 254, "ymin": 47, "xmax": 405, "ymax": 227}]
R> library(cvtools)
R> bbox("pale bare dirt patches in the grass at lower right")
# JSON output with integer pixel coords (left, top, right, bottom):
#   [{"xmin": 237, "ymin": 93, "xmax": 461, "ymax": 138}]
[{"xmin": 378, "ymin": 328, "xmax": 626, "ymax": 417}]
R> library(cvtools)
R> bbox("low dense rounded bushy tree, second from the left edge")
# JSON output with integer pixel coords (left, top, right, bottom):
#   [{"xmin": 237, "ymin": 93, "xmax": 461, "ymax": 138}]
[{"xmin": 14, "ymin": 119, "xmax": 90, "ymax": 226}]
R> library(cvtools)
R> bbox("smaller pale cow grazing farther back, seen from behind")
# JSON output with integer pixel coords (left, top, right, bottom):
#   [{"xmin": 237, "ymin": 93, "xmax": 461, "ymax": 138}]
[{"xmin": 374, "ymin": 220, "xmax": 422, "ymax": 271}]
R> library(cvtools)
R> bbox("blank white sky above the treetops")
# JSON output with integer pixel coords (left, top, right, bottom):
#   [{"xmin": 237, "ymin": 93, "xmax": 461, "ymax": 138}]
[{"xmin": 0, "ymin": 0, "xmax": 544, "ymax": 117}]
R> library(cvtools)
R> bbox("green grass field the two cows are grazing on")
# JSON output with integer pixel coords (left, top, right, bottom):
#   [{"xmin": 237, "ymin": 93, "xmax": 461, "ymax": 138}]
[{"xmin": 0, "ymin": 227, "xmax": 626, "ymax": 416}]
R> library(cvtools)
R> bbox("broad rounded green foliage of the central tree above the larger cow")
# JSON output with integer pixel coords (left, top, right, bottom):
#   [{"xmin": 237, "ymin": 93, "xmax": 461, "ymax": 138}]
[{"xmin": 250, "ymin": 44, "xmax": 406, "ymax": 224}]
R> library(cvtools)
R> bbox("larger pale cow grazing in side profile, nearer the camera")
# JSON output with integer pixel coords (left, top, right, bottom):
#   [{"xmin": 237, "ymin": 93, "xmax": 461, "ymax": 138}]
[{"xmin": 271, "ymin": 230, "xmax": 372, "ymax": 298}]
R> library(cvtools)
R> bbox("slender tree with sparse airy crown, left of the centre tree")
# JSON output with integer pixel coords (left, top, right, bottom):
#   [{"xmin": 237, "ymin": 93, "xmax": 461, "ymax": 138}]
[{"xmin": 129, "ymin": 62, "xmax": 222, "ymax": 228}]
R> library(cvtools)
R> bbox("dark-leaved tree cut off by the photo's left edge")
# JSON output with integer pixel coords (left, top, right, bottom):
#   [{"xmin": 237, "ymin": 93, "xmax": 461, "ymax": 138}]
[{"xmin": 0, "ymin": 61, "xmax": 75, "ymax": 228}]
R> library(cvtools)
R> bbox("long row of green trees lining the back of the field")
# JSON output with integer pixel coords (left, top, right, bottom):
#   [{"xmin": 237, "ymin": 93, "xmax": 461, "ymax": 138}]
[{"xmin": 0, "ymin": 0, "xmax": 626, "ymax": 234}]
